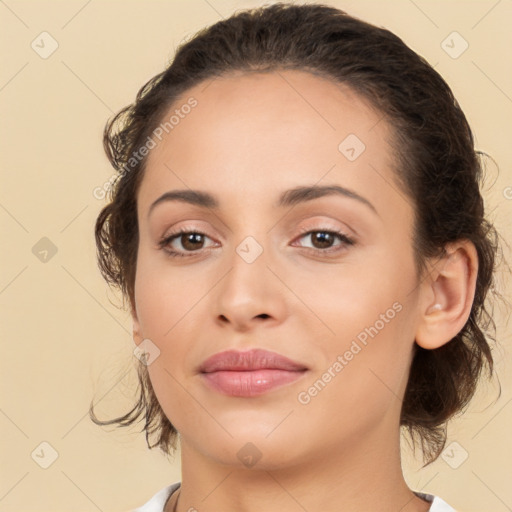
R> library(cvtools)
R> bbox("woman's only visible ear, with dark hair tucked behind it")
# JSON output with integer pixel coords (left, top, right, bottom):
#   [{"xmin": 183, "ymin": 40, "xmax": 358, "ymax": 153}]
[{"xmin": 416, "ymin": 240, "xmax": 478, "ymax": 349}]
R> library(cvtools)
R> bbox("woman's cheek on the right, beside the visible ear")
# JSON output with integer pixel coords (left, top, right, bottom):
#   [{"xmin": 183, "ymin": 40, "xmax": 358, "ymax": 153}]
[{"xmin": 298, "ymin": 251, "xmax": 417, "ymax": 400}]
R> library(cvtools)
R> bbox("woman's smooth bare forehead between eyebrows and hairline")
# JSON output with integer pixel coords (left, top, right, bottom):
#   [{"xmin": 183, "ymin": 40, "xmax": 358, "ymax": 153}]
[{"xmin": 138, "ymin": 70, "xmax": 402, "ymax": 216}]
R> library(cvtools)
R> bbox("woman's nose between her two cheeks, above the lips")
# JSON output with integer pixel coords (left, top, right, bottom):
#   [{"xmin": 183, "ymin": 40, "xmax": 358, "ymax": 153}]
[{"xmin": 214, "ymin": 243, "xmax": 287, "ymax": 332}]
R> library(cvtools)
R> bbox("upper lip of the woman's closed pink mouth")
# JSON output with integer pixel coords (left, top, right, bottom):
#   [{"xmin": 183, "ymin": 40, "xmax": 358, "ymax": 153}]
[{"xmin": 199, "ymin": 349, "xmax": 307, "ymax": 373}]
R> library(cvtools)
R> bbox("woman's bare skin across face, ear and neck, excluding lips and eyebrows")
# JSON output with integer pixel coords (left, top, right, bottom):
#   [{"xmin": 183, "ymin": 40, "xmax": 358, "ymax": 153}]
[{"xmin": 132, "ymin": 71, "xmax": 477, "ymax": 512}]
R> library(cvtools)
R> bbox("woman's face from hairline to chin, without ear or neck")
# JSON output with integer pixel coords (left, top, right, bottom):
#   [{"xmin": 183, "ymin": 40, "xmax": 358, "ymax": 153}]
[{"xmin": 133, "ymin": 71, "xmax": 420, "ymax": 468}]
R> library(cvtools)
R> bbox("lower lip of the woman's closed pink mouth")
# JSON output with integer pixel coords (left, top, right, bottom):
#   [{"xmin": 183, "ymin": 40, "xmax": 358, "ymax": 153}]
[{"xmin": 201, "ymin": 369, "xmax": 305, "ymax": 397}]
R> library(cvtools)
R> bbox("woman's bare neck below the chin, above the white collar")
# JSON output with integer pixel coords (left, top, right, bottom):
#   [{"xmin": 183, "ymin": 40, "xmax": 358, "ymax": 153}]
[{"xmin": 172, "ymin": 424, "xmax": 430, "ymax": 512}]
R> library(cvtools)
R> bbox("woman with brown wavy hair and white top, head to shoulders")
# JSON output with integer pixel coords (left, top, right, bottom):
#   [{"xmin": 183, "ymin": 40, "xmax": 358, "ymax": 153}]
[{"xmin": 91, "ymin": 4, "xmax": 497, "ymax": 512}]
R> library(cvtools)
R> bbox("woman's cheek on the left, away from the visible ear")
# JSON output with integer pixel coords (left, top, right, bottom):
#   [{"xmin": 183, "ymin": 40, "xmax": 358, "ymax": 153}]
[{"xmin": 135, "ymin": 251, "xmax": 215, "ymax": 431}]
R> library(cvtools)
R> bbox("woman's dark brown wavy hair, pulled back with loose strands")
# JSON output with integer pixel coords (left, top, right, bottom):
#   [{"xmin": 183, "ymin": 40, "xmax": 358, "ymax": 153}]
[{"xmin": 89, "ymin": 3, "xmax": 502, "ymax": 465}]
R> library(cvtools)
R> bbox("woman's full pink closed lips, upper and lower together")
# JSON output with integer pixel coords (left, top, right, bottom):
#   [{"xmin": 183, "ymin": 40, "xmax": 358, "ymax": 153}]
[{"xmin": 199, "ymin": 349, "xmax": 307, "ymax": 397}]
